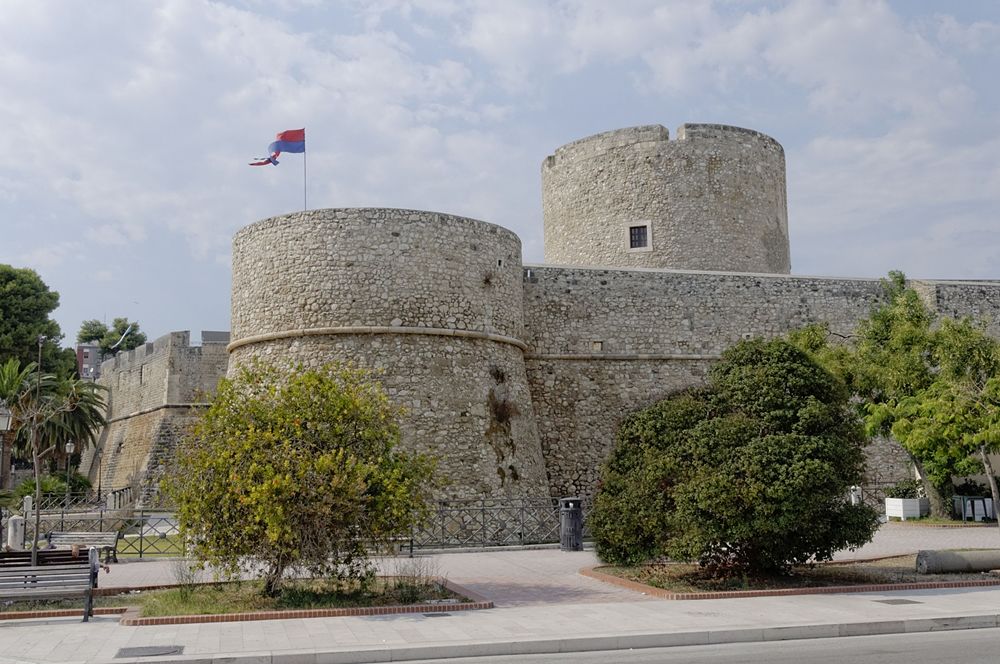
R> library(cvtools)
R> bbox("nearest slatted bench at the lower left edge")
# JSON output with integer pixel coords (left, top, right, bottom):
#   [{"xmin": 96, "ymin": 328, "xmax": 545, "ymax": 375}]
[{"xmin": 0, "ymin": 548, "xmax": 99, "ymax": 622}]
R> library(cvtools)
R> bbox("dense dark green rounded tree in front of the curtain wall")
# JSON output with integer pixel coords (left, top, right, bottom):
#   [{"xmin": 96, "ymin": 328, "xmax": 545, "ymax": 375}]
[{"xmin": 590, "ymin": 340, "xmax": 877, "ymax": 575}]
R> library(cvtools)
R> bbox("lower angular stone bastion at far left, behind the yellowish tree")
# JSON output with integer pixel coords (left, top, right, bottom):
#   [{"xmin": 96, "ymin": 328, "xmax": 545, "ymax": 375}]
[{"xmin": 80, "ymin": 332, "xmax": 229, "ymax": 506}]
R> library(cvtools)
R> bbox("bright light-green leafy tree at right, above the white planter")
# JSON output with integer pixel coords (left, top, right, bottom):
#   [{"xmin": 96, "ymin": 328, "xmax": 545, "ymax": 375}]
[{"xmin": 790, "ymin": 272, "xmax": 1000, "ymax": 518}]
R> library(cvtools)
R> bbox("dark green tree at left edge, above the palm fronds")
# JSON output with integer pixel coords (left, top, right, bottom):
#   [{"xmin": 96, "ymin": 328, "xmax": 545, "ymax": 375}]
[{"xmin": 0, "ymin": 264, "xmax": 76, "ymax": 376}]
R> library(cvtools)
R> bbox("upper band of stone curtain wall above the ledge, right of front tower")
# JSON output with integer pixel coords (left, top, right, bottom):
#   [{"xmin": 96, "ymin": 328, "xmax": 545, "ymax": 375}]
[{"xmin": 524, "ymin": 265, "xmax": 882, "ymax": 357}]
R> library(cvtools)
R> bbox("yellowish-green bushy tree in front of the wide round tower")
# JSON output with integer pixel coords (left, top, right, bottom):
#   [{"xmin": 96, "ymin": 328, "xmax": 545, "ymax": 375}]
[{"xmin": 164, "ymin": 363, "xmax": 432, "ymax": 595}]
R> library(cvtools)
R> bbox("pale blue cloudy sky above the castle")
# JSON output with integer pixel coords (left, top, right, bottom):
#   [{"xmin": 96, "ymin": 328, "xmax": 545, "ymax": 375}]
[{"xmin": 0, "ymin": 0, "xmax": 1000, "ymax": 341}]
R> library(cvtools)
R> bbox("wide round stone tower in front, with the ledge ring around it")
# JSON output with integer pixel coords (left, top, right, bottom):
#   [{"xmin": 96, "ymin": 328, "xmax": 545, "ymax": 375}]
[{"xmin": 229, "ymin": 208, "xmax": 548, "ymax": 498}]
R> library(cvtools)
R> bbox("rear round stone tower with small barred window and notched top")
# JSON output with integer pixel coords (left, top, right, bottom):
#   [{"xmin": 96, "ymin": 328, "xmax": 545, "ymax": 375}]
[{"xmin": 542, "ymin": 124, "xmax": 791, "ymax": 274}]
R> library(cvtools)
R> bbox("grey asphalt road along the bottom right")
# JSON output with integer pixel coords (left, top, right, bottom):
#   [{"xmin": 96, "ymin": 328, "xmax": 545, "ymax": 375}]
[{"xmin": 404, "ymin": 629, "xmax": 1000, "ymax": 664}]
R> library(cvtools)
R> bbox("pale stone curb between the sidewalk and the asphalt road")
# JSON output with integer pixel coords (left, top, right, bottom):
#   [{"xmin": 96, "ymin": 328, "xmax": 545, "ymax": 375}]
[{"xmin": 94, "ymin": 614, "xmax": 1000, "ymax": 664}]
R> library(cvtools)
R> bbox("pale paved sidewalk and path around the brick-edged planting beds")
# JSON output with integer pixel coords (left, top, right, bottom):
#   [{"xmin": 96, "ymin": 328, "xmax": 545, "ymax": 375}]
[{"xmin": 0, "ymin": 524, "xmax": 1000, "ymax": 664}]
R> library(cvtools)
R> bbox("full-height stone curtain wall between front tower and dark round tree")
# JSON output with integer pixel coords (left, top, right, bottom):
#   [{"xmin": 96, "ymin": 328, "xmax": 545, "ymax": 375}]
[{"xmin": 524, "ymin": 265, "xmax": 909, "ymax": 495}]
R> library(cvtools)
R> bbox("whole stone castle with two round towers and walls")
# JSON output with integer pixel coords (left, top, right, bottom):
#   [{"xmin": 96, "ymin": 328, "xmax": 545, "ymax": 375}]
[{"xmin": 82, "ymin": 124, "xmax": 1000, "ymax": 503}]
